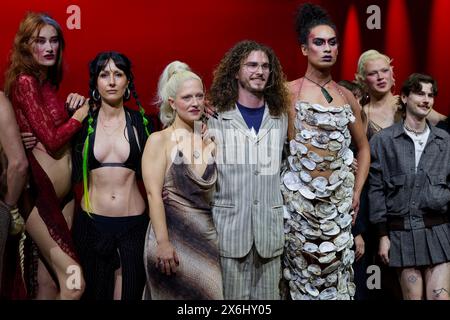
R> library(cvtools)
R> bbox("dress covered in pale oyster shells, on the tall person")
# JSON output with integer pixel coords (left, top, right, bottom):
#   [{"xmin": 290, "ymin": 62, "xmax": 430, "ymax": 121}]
[{"xmin": 281, "ymin": 101, "xmax": 355, "ymax": 300}]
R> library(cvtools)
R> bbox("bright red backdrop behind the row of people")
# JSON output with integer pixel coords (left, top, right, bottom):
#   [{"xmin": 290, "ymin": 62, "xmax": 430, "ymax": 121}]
[{"xmin": 0, "ymin": 0, "xmax": 450, "ymax": 114}]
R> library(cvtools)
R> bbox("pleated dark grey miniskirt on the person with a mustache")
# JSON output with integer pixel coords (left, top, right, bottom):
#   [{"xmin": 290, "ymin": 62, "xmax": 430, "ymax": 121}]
[{"xmin": 389, "ymin": 223, "xmax": 450, "ymax": 268}]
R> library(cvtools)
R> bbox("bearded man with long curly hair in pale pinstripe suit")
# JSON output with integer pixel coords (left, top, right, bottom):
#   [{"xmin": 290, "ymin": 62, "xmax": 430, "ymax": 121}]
[{"xmin": 208, "ymin": 41, "xmax": 288, "ymax": 300}]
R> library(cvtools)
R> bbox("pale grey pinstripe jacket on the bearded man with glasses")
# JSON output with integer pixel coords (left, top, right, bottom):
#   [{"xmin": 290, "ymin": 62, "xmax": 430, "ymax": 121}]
[{"xmin": 208, "ymin": 106, "xmax": 287, "ymax": 258}]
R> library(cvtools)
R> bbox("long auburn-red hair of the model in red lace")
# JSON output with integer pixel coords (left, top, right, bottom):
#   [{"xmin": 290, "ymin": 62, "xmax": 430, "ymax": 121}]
[{"xmin": 4, "ymin": 12, "xmax": 64, "ymax": 95}]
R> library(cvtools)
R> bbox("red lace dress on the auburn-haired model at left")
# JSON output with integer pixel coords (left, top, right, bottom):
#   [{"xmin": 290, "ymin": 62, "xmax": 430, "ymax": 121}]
[{"xmin": 10, "ymin": 74, "xmax": 81, "ymax": 298}]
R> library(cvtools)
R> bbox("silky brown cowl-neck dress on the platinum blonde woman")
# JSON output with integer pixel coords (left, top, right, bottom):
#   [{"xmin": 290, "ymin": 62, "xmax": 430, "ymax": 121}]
[{"xmin": 143, "ymin": 151, "xmax": 223, "ymax": 300}]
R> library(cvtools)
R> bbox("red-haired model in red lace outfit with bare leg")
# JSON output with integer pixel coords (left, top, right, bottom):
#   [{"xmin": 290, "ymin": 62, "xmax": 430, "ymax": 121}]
[{"xmin": 5, "ymin": 13, "xmax": 89, "ymax": 299}]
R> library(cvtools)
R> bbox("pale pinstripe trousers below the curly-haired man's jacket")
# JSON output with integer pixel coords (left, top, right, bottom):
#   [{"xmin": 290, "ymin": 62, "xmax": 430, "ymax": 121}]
[{"xmin": 220, "ymin": 246, "xmax": 281, "ymax": 300}]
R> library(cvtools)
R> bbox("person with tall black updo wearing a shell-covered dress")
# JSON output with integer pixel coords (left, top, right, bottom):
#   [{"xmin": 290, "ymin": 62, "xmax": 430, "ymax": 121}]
[{"xmin": 281, "ymin": 4, "xmax": 370, "ymax": 300}]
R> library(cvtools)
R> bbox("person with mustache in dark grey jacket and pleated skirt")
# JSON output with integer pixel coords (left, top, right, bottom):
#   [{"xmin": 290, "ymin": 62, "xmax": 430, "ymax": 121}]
[{"xmin": 369, "ymin": 73, "xmax": 450, "ymax": 300}]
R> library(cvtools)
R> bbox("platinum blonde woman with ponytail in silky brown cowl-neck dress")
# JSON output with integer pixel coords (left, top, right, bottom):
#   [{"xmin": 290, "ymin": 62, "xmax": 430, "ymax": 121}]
[{"xmin": 142, "ymin": 61, "xmax": 223, "ymax": 299}]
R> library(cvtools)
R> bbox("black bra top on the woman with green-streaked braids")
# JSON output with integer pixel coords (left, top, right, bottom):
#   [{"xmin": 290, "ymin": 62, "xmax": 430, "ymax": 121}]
[{"xmin": 88, "ymin": 110, "xmax": 141, "ymax": 172}]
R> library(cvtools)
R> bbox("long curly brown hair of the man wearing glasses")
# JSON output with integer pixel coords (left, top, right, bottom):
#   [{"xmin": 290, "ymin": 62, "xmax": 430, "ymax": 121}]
[{"xmin": 208, "ymin": 40, "xmax": 289, "ymax": 116}]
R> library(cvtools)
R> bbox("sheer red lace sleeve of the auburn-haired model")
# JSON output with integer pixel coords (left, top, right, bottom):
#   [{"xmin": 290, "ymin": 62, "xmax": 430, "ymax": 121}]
[{"xmin": 11, "ymin": 75, "xmax": 81, "ymax": 153}]
